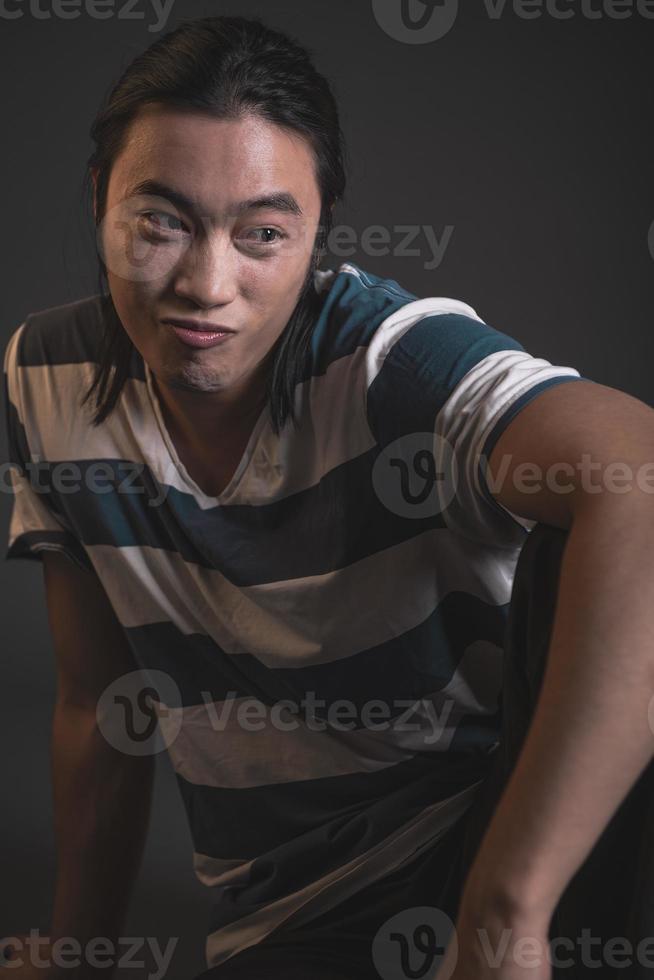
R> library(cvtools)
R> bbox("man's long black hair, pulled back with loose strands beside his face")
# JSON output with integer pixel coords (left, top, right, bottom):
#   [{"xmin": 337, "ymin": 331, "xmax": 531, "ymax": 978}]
[{"xmin": 82, "ymin": 16, "xmax": 346, "ymax": 432}]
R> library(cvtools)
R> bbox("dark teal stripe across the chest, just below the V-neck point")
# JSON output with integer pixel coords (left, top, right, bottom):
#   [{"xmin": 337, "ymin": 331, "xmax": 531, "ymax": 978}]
[{"xmin": 2, "ymin": 428, "xmax": 452, "ymax": 586}]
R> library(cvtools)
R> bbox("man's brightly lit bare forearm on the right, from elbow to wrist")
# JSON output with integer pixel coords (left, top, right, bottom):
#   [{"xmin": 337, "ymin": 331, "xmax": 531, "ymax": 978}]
[{"xmin": 462, "ymin": 494, "xmax": 654, "ymax": 917}]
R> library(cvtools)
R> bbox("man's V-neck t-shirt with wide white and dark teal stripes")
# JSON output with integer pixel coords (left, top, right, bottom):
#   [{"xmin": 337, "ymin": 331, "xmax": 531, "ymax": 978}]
[{"xmin": 4, "ymin": 263, "xmax": 585, "ymax": 967}]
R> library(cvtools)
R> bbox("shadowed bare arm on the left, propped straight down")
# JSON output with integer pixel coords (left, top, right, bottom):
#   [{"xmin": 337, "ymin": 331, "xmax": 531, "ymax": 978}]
[{"xmin": 35, "ymin": 552, "xmax": 154, "ymax": 980}]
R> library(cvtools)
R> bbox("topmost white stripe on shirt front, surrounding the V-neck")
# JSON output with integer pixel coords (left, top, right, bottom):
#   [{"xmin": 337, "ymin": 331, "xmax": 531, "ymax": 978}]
[{"xmin": 10, "ymin": 348, "xmax": 375, "ymax": 510}]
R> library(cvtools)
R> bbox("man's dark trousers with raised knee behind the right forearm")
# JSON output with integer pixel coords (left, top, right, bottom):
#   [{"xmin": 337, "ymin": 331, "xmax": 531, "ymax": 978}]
[{"xmin": 196, "ymin": 524, "xmax": 654, "ymax": 980}]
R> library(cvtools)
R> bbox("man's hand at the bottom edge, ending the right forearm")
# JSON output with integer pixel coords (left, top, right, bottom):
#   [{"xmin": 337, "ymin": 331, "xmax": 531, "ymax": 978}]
[{"xmin": 438, "ymin": 908, "xmax": 552, "ymax": 980}]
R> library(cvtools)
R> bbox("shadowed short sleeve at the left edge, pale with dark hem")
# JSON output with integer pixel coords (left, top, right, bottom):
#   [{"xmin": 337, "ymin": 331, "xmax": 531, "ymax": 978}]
[{"xmin": 3, "ymin": 323, "xmax": 93, "ymax": 570}]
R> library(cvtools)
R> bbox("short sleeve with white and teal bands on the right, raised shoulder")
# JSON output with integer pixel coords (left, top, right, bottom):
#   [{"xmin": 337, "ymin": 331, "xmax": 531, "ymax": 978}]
[{"xmin": 368, "ymin": 298, "xmax": 590, "ymax": 548}]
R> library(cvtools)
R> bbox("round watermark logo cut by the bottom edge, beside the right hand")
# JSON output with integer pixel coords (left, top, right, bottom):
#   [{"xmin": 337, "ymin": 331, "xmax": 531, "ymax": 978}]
[{"xmin": 372, "ymin": 905, "xmax": 457, "ymax": 980}]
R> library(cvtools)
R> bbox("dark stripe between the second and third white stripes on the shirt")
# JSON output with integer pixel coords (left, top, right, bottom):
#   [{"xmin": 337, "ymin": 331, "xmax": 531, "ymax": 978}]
[{"xmin": 125, "ymin": 592, "xmax": 508, "ymax": 704}]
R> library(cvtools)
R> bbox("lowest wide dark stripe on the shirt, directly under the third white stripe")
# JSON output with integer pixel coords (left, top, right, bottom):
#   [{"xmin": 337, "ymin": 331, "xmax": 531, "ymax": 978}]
[{"xmin": 181, "ymin": 741, "xmax": 491, "ymax": 868}]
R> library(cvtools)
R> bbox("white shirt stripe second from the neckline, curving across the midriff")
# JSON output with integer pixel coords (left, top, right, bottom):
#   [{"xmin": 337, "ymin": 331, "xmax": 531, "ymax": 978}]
[{"xmin": 86, "ymin": 528, "xmax": 518, "ymax": 667}]
